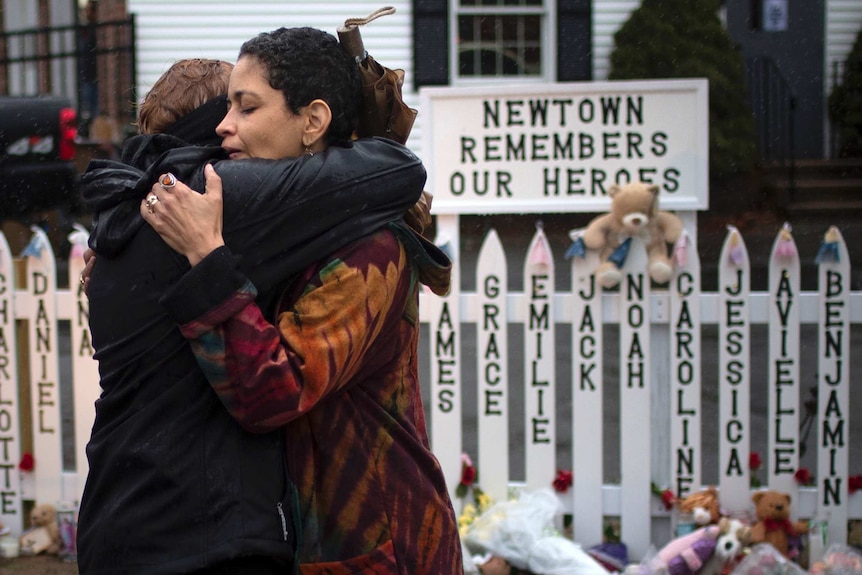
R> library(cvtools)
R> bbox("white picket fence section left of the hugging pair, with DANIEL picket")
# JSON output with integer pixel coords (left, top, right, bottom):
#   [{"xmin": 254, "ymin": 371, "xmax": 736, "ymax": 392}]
[{"xmin": 0, "ymin": 227, "xmax": 99, "ymax": 534}]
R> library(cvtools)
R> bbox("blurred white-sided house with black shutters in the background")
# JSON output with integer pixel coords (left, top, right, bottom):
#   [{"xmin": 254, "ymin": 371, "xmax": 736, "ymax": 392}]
[{"xmin": 0, "ymin": 0, "xmax": 862, "ymax": 159}]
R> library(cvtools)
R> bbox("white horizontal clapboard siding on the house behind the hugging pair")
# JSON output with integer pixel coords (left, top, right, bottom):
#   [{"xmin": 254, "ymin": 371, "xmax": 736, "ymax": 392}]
[{"xmin": 126, "ymin": 0, "xmax": 862, "ymax": 155}]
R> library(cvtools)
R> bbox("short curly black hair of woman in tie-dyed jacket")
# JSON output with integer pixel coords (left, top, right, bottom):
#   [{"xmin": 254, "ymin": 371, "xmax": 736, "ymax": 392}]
[{"xmin": 239, "ymin": 27, "xmax": 361, "ymax": 144}]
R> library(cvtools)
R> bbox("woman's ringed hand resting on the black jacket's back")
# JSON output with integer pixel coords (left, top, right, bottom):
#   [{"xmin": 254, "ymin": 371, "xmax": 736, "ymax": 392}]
[{"xmin": 141, "ymin": 164, "xmax": 224, "ymax": 266}]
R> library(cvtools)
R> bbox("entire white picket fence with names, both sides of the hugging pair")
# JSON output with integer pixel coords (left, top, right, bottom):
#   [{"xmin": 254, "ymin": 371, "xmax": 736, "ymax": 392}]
[{"xmin": 0, "ymin": 218, "xmax": 862, "ymax": 558}]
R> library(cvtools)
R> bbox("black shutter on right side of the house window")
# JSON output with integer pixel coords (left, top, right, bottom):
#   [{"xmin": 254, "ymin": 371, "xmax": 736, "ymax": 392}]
[{"xmin": 557, "ymin": 0, "xmax": 593, "ymax": 82}]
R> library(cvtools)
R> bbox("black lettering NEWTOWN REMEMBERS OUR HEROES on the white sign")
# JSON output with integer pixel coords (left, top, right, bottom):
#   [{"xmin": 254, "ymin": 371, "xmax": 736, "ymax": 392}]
[{"xmin": 449, "ymin": 95, "xmax": 680, "ymax": 197}]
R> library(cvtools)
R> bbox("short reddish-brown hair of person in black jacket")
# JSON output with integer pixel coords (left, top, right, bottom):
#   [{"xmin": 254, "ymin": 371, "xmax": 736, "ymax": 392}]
[{"xmin": 138, "ymin": 58, "xmax": 233, "ymax": 134}]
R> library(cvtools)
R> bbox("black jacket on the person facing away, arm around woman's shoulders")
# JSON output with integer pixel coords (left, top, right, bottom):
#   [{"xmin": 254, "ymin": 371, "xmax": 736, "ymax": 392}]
[{"xmin": 78, "ymin": 136, "xmax": 425, "ymax": 575}]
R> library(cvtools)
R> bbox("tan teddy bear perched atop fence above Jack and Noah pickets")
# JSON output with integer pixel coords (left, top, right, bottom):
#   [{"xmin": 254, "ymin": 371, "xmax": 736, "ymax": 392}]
[{"xmin": 582, "ymin": 182, "xmax": 682, "ymax": 288}]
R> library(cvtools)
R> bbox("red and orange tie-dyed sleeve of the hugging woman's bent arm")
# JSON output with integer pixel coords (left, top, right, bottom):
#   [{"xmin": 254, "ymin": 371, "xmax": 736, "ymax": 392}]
[{"xmin": 165, "ymin": 233, "xmax": 405, "ymax": 432}]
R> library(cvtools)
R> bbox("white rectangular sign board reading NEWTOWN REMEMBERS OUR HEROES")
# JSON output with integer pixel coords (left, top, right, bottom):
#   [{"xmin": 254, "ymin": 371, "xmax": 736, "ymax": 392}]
[{"xmin": 419, "ymin": 79, "xmax": 709, "ymax": 214}]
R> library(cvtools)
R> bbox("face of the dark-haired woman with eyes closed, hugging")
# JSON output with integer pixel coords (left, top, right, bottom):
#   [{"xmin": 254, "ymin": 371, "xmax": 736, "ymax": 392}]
[{"xmin": 216, "ymin": 56, "xmax": 305, "ymax": 160}]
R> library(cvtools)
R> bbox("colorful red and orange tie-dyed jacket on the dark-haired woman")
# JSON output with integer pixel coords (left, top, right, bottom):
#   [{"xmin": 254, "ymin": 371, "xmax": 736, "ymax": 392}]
[{"xmin": 164, "ymin": 230, "xmax": 462, "ymax": 575}]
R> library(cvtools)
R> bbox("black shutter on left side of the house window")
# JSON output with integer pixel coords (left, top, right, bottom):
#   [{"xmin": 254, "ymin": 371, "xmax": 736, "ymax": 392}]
[{"xmin": 413, "ymin": 0, "xmax": 449, "ymax": 89}]
